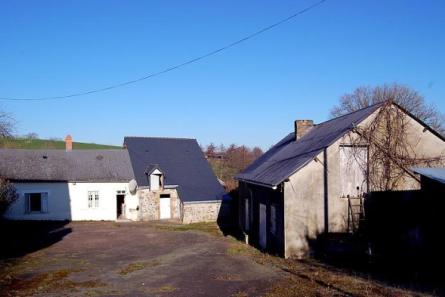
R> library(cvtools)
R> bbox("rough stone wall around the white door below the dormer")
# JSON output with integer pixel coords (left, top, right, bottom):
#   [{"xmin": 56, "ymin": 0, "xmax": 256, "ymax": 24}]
[{"xmin": 138, "ymin": 189, "xmax": 181, "ymax": 221}]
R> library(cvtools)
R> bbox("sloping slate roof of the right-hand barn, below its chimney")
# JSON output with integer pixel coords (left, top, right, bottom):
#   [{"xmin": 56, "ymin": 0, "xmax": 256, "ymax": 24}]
[{"xmin": 236, "ymin": 103, "xmax": 382, "ymax": 187}]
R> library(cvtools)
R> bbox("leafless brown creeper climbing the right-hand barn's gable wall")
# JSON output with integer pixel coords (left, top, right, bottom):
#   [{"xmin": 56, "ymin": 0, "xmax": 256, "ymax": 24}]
[{"xmin": 349, "ymin": 100, "xmax": 445, "ymax": 191}]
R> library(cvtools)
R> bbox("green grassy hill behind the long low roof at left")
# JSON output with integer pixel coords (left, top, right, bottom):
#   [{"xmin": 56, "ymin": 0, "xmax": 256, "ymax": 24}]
[{"xmin": 0, "ymin": 138, "xmax": 121, "ymax": 150}]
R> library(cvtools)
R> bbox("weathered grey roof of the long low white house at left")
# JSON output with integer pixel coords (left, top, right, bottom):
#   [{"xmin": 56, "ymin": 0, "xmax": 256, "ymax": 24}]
[{"xmin": 0, "ymin": 149, "xmax": 134, "ymax": 182}]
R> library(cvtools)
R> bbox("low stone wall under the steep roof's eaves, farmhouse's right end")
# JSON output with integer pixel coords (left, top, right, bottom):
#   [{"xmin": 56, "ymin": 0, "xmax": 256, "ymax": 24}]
[{"xmin": 182, "ymin": 201, "xmax": 221, "ymax": 224}]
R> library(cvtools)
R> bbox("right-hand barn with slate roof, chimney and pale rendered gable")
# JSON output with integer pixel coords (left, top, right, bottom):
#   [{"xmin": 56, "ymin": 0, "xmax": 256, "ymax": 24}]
[{"xmin": 236, "ymin": 103, "xmax": 445, "ymax": 257}]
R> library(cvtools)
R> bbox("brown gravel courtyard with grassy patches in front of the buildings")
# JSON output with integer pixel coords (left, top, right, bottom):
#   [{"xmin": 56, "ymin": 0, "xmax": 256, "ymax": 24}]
[{"xmin": 0, "ymin": 222, "xmax": 436, "ymax": 297}]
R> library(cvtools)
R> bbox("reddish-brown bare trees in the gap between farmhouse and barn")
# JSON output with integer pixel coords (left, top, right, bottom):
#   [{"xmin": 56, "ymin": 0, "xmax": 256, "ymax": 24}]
[{"xmin": 204, "ymin": 143, "xmax": 263, "ymax": 190}]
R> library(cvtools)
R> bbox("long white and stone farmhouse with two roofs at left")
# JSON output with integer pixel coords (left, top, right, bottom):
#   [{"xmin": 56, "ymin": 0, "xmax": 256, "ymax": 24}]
[{"xmin": 0, "ymin": 136, "xmax": 224, "ymax": 223}]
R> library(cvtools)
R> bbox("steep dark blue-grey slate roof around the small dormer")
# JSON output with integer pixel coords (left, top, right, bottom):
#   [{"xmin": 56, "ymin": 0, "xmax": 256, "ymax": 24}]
[{"xmin": 124, "ymin": 137, "xmax": 225, "ymax": 202}]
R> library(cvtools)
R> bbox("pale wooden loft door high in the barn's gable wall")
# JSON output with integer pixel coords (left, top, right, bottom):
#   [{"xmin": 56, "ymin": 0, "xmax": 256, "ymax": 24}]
[{"xmin": 340, "ymin": 146, "xmax": 368, "ymax": 197}]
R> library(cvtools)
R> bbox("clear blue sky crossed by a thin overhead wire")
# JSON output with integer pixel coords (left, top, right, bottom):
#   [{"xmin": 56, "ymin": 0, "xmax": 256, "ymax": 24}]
[{"xmin": 0, "ymin": 0, "xmax": 445, "ymax": 148}]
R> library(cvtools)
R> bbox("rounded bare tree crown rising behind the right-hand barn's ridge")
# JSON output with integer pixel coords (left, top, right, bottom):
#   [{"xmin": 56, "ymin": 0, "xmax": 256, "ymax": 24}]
[{"xmin": 331, "ymin": 84, "xmax": 445, "ymax": 135}]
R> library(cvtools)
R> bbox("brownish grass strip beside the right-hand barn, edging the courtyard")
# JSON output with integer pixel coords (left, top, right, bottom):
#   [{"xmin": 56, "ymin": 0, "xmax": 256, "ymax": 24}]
[{"xmin": 226, "ymin": 239, "xmax": 426, "ymax": 297}]
